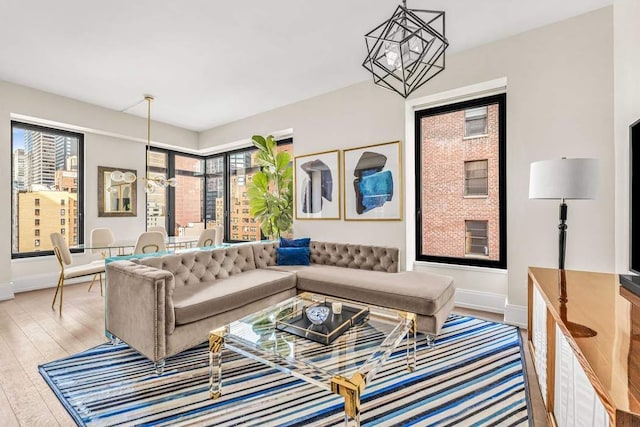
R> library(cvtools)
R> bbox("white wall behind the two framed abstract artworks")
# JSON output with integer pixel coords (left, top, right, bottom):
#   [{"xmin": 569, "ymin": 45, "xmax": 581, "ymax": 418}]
[{"xmin": 200, "ymin": 83, "xmax": 405, "ymax": 265}]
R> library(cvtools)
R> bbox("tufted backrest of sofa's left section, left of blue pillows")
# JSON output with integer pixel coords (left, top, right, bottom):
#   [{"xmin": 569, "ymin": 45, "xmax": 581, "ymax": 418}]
[{"xmin": 133, "ymin": 245, "xmax": 256, "ymax": 288}]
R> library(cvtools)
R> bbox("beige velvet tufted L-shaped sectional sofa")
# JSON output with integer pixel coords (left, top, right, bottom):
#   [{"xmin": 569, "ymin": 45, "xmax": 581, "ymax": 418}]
[{"xmin": 105, "ymin": 241, "xmax": 455, "ymax": 368}]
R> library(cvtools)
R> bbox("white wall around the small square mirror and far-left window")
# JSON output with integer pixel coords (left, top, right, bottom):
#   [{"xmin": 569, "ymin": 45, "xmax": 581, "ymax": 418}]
[{"xmin": 0, "ymin": 81, "xmax": 198, "ymax": 299}]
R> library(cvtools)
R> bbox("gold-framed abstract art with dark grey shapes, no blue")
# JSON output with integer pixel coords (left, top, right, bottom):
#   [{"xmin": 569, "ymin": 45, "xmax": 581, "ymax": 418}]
[{"xmin": 294, "ymin": 150, "xmax": 340, "ymax": 219}]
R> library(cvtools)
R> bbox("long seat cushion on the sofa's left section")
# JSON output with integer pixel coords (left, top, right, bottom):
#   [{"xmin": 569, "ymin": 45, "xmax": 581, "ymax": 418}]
[{"xmin": 173, "ymin": 269, "xmax": 296, "ymax": 325}]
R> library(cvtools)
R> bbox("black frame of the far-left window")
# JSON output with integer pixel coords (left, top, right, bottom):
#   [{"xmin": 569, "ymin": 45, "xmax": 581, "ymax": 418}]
[{"xmin": 10, "ymin": 120, "xmax": 85, "ymax": 259}]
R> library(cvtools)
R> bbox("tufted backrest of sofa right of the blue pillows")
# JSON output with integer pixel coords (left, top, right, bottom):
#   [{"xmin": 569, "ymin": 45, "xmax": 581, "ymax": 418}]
[{"xmin": 310, "ymin": 241, "xmax": 399, "ymax": 273}]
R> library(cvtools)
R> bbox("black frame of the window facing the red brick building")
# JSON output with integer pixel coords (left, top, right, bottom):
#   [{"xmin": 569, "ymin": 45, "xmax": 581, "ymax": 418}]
[{"xmin": 414, "ymin": 93, "xmax": 507, "ymax": 269}]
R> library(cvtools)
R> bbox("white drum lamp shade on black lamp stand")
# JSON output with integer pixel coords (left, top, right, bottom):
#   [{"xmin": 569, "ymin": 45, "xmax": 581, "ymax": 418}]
[{"xmin": 529, "ymin": 159, "xmax": 599, "ymax": 199}]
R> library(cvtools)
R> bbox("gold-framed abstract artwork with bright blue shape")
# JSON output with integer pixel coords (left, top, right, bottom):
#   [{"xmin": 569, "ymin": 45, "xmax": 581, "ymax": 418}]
[{"xmin": 342, "ymin": 141, "xmax": 402, "ymax": 221}]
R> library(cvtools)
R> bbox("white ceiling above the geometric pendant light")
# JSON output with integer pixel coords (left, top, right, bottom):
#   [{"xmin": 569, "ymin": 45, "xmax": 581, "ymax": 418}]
[{"xmin": 0, "ymin": 0, "xmax": 612, "ymax": 131}]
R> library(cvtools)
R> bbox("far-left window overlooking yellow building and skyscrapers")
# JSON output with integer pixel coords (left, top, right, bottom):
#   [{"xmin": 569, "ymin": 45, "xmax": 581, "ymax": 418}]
[{"xmin": 11, "ymin": 122, "xmax": 83, "ymax": 258}]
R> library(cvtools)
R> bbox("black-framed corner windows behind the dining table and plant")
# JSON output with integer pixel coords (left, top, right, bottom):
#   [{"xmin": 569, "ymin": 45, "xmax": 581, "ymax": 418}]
[{"xmin": 147, "ymin": 139, "xmax": 293, "ymax": 241}]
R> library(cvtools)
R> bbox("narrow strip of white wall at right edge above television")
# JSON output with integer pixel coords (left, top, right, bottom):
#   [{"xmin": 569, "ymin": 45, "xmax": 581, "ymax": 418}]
[{"xmin": 613, "ymin": 0, "xmax": 640, "ymax": 273}]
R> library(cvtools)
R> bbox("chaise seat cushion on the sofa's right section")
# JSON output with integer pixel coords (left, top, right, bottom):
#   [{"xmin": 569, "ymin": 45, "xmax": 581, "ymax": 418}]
[{"xmin": 296, "ymin": 265, "xmax": 455, "ymax": 316}]
